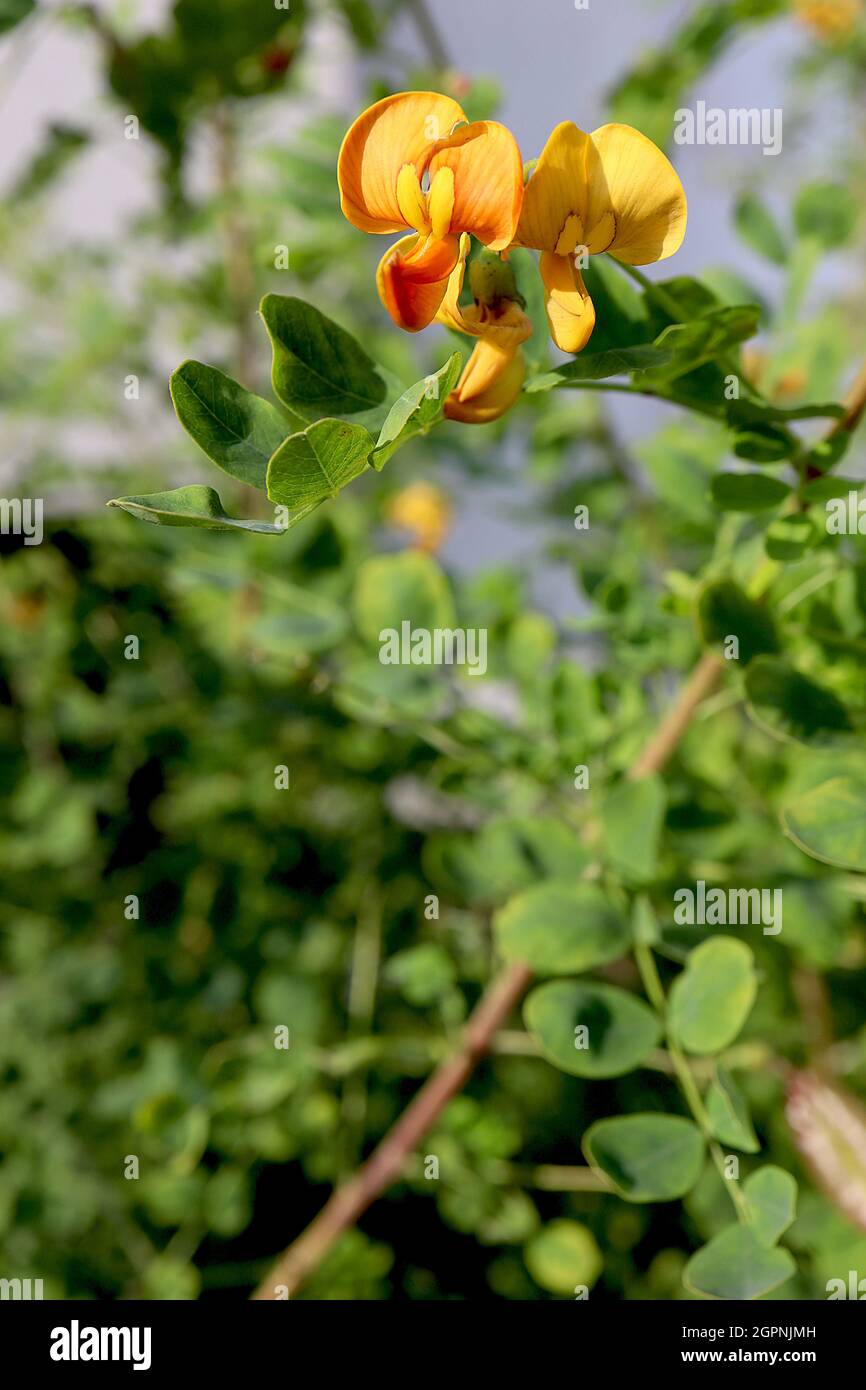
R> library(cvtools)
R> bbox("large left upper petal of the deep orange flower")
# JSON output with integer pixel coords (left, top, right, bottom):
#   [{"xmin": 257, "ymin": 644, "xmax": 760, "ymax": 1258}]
[{"xmin": 336, "ymin": 92, "xmax": 466, "ymax": 232}]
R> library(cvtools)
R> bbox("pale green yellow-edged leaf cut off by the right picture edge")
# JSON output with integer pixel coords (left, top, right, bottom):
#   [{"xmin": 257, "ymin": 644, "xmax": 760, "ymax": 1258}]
[{"xmin": 781, "ymin": 776, "xmax": 866, "ymax": 873}]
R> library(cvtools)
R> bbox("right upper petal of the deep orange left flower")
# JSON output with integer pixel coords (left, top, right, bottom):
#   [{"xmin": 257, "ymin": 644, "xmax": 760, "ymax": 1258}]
[{"xmin": 430, "ymin": 121, "xmax": 523, "ymax": 252}]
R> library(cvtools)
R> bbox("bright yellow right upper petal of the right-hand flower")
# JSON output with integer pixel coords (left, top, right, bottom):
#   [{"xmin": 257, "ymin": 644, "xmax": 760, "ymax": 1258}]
[{"xmin": 587, "ymin": 125, "xmax": 687, "ymax": 265}]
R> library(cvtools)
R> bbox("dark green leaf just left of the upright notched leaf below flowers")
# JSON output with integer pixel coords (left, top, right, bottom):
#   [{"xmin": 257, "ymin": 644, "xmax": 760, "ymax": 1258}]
[{"xmin": 168, "ymin": 360, "xmax": 289, "ymax": 491}]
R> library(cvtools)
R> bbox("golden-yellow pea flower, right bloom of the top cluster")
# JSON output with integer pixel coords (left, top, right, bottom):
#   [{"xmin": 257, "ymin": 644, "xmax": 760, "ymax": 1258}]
[{"xmin": 516, "ymin": 121, "xmax": 687, "ymax": 353}]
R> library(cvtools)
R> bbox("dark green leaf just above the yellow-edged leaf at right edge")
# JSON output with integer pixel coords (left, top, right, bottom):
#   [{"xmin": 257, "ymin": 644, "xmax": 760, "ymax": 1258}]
[{"xmin": 745, "ymin": 656, "xmax": 852, "ymax": 746}]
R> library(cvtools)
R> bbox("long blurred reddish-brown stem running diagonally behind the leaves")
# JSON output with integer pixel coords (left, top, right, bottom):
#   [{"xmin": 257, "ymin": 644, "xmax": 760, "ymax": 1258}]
[{"xmin": 253, "ymin": 644, "xmax": 723, "ymax": 1300}]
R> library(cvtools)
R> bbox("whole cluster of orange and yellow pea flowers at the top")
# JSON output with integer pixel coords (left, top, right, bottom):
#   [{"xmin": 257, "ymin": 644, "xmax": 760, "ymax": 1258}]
[{"xmin": 338, "ymin": 92, "xmax": 687, "ymax": 424}]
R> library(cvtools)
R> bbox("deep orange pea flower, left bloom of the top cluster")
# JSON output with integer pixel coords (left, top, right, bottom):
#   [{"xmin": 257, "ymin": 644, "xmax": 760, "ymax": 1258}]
[{"xmin": 338, "ymin": 92, "xmax": 523, "ymax": 332}]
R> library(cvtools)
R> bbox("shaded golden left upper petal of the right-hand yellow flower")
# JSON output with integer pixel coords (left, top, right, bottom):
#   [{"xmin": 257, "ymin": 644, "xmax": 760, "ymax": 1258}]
[{"xmin": 516, "ymin": 121, "xmax": 589, "ymax": 252}]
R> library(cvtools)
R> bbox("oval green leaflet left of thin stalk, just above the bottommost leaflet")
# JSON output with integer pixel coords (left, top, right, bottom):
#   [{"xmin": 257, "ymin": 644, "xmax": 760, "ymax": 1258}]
[{"xmin": 582, "ymin": 1115, "xmax": 703, "ymax": 1202}]
